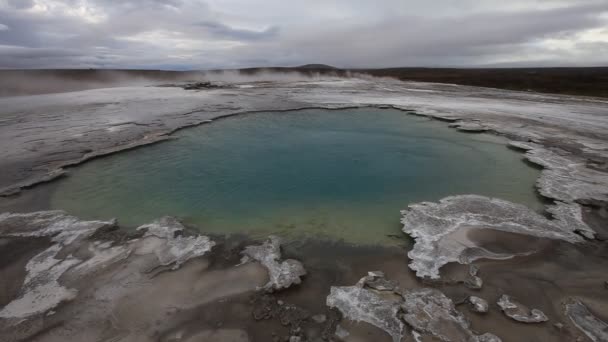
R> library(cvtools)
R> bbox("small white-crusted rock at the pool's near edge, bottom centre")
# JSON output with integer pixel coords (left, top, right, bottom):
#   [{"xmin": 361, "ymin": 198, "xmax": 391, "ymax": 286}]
[{"xmin": 241, "ymin": 236, "xmax": 306, "ymax": 292}]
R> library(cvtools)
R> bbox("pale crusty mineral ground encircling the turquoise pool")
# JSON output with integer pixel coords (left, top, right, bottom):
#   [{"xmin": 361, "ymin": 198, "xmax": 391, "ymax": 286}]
[{"xmin": 0, "ymin": 78, "xmax": 608, "ymax": 342}]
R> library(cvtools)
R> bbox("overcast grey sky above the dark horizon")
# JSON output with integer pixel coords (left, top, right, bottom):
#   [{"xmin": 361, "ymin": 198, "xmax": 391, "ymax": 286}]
[{"xmin": 0, "ymin": 0, "xmax": 608, "ymax": 69}]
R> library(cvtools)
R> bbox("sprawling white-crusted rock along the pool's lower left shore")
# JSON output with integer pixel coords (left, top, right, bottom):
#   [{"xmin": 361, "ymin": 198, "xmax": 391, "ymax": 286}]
[{"xmin": 0, "ymin": 211, "xmax": 214, "ymax": 318}]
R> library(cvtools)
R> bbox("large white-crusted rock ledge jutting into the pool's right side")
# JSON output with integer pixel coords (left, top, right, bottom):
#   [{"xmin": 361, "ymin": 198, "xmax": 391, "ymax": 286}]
[{"xmin": 401, "ymin": 195, "xmax": 583, "ymax": 279}]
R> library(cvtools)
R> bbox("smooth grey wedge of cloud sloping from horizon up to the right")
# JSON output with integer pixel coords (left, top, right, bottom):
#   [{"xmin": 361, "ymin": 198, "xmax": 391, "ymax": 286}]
[{"xmin": 232, "ymin": 1, "xmax": 608, "ymax": 67}]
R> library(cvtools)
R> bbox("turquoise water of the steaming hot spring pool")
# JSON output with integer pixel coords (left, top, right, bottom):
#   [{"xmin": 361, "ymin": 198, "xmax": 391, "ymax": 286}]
[{"xmin": 51, "ymin": 109, "xmax": 541, "ymax": 244}]
